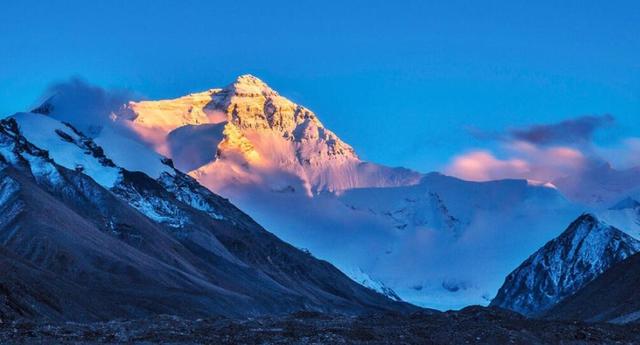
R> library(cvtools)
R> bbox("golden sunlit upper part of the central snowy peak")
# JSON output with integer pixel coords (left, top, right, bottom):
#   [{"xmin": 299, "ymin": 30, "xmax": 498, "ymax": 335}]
[{"xmin": 120, "ymin": 75, "xmax": 420, "ymax": 195}]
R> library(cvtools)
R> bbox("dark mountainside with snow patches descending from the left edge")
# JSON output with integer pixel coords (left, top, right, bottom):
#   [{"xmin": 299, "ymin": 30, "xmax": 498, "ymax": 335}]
[{"xmin": 0, "ymin": 113, "xmax": 411, "ymax": 320}]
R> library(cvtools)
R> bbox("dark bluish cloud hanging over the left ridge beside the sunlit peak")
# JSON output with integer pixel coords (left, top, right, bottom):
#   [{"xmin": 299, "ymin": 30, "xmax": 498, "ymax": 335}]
[{"xmin": 35, "ymin": 78, "xmax": 136, "ymax": 136}]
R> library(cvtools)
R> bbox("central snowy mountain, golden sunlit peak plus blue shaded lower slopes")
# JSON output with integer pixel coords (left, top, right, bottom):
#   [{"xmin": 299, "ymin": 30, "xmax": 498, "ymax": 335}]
[{"xmin": 35, "ymin": 76, "xmax": 582, "ymax": 309}]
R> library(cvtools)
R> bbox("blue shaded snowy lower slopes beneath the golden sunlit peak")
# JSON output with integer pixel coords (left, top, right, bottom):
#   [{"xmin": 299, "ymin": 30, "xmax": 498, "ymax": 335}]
[{"xmin": 204, "ymin": 174, "xmax": 581, "ymax": 309}]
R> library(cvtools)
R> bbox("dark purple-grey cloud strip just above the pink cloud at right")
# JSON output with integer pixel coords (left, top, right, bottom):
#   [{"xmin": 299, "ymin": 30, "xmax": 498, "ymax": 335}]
[{"xmin": 509, "ymin": 115, "xmax": 615, "ymax": 145}]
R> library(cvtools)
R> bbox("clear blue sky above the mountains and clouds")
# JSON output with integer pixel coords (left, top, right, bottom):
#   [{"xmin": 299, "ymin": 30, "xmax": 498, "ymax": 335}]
[{"xmin": 0, "ymin": 0, "xmax": 640, "ymax": 171}]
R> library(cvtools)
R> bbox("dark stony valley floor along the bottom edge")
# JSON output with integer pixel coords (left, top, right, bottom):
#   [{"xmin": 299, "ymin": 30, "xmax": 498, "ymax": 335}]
[{"xmin": 0, "ymin": 307, "xmax": 640, "ymax": 344}]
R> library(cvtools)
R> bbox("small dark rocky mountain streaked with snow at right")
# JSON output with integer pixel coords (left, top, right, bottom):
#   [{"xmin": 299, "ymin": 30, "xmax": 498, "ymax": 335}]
[{"xmin": 491, "ymin": 214, "xmax": 640, "ymax": 316}]
